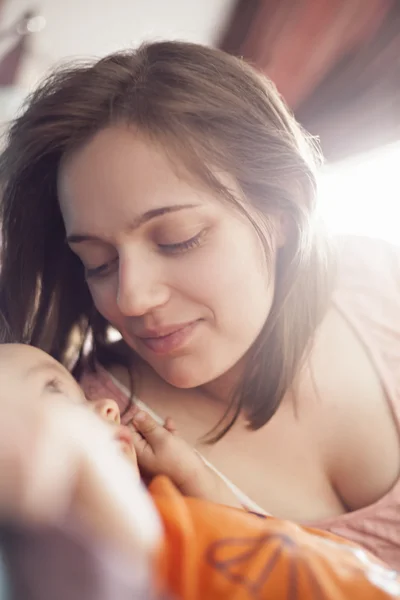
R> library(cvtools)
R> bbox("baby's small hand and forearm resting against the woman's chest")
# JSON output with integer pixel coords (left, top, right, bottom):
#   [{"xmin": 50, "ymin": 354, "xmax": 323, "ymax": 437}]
[{"xmin": 132, "ymin": 411, "xmax": 241, "ymax": 507}]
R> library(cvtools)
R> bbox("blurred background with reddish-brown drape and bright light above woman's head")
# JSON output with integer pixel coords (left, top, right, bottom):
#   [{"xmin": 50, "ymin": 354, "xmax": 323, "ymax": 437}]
[{"xmin": 0, "ymin": 0, "xmax": 400, "ymax": 243}]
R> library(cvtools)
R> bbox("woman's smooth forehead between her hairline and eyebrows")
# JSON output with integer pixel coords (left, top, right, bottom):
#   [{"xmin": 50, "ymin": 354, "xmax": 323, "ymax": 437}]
[{"xmin": 58, "ymin": 126, "xmax": 227, "ymax": 234}]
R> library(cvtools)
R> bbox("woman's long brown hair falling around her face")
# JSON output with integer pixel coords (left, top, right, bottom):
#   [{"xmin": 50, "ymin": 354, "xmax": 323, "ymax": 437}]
[{"xmin": 0, "ymin": 42, "xmax": 331, "ymax": 439}]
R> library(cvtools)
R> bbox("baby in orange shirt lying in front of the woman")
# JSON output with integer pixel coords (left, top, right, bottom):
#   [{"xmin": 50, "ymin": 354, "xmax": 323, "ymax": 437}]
[{"xmin": 0, "ymin": 344, "xmax": 400, "ymax": 600}]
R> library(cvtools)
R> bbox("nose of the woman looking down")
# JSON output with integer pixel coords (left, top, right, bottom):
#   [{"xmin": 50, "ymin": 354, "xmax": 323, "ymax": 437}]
[{"xmin": 117, "ymin": 251, "xmax": 170, "ymax": 317}]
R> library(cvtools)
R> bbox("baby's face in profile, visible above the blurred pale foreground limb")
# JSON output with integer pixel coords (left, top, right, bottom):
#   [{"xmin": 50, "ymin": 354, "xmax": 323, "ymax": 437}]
[{"xmin": 0, "ymin": 344, "xmax": 137, "ymax": 469}]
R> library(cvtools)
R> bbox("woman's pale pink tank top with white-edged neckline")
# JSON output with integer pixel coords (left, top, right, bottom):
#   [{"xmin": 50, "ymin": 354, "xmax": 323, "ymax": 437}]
[{"xmin": 81, "ymin": 236, "xmax": 400, "ymax": 571}]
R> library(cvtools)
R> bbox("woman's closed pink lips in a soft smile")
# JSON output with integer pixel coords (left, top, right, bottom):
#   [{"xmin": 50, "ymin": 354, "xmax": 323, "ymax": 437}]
[{"xmin": 137, "ymin": 319, "xmax": 201, "ymax": 354}]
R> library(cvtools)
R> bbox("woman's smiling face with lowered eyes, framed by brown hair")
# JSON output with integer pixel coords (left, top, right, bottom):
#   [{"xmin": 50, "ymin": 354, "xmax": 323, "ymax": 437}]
[{"xmin": 59, "ymin": 127, "xmax": 275, "ymax": 388}]
